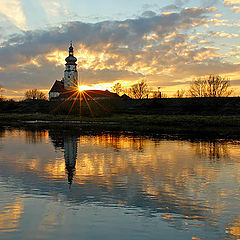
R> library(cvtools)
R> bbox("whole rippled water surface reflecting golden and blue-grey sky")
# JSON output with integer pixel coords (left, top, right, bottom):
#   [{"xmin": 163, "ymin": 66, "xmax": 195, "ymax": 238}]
[{"xmin": 0, "ymin": 126, "xmax": 240, "ymax": 240}]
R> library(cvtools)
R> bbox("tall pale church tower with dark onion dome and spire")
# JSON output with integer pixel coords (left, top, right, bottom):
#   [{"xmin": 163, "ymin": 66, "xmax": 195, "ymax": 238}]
[{"xmin": 63, "ymin": 41, "xmax": 78, "ymax": 90}]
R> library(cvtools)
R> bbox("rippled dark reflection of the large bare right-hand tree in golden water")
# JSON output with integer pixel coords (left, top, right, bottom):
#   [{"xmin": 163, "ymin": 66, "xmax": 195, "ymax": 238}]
[{"xmin": 192, "ymin": 142, "xmax": 229, "ymax": 160}]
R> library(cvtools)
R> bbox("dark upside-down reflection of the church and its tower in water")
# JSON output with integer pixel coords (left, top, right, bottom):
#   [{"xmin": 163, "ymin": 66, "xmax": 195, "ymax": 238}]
[{"xmin": 49, "ymin": 131, "xmax": 77, "ymax": 184}]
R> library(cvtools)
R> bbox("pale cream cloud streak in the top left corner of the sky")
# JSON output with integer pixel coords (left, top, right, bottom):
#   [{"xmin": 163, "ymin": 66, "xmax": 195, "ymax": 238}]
[{"xmin": 0, "ymin": 0, "xmax": 26, "ymax": 30}]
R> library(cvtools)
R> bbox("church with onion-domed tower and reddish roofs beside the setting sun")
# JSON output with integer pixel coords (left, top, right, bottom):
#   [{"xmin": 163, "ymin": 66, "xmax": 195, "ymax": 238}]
[{"xmin": 49, "ymin": 42, "xmax": 120, "ymax": 101}]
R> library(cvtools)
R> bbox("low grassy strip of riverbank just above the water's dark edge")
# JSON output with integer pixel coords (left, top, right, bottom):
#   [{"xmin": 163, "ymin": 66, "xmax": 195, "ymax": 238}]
[{"xmin": 0, "ymin": 113, "xmax": 240, "ymax": 127}]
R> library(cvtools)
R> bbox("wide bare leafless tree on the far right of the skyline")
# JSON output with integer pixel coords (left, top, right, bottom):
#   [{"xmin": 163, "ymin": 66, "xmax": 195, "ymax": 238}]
[{"xmin": 188, "ymin": 75, "xmax": 233, "ymax": 97}]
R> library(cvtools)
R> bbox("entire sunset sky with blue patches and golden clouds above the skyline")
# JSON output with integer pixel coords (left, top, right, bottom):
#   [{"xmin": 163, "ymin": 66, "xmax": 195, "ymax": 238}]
[{"xmin": 0, "ymin": 0, "xmax": 240, "ymax": 99}]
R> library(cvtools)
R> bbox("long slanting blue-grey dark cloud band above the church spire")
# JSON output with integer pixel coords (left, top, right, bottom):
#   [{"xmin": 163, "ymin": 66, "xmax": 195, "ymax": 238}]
[{"xmin": 0, "ymin": 8, "xmax": 212, "ymax": 67}]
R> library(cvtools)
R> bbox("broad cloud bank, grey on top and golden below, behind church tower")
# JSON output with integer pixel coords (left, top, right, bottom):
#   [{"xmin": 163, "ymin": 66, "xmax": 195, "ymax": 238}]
[{"xmin": 0, "ymin": 7, "xmax": 238, "ymax": 97}]
